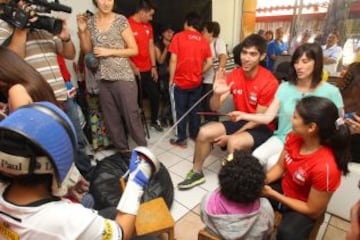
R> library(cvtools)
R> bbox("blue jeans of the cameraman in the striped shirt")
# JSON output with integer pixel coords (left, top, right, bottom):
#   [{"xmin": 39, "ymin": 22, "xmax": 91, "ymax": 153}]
[{"xmin": 64, "ymin": 98, "xmax": 91, "ymax": 177}]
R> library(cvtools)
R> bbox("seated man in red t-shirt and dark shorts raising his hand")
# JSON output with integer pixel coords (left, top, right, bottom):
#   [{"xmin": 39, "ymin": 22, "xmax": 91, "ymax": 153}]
[{"xmin": 178, "ymin": 34, "xmax": 278, "ymax": 190}]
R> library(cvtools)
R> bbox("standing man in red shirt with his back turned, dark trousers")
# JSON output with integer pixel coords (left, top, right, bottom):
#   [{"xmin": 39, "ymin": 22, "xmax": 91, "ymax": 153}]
[{"xmin": 169, "ymin": 12, "xmax": 212, "ymax": 148}]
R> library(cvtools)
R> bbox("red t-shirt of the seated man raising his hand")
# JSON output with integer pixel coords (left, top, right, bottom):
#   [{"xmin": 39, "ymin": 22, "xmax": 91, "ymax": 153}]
[{"xmin": 226, "ymin": 66, "xmax": 279, "ymax": 129}]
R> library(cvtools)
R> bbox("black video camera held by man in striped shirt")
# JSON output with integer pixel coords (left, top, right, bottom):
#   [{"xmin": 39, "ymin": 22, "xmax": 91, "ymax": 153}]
[{"xmin": 0, "ymin": 0, "xmax": 72, "ymax": 35}]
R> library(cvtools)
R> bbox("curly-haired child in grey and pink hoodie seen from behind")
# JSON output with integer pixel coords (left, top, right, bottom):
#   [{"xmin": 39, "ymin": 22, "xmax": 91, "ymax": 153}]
[{"xmin": 200, "ymin": 151, "xmax": 274, "ymax": 239}]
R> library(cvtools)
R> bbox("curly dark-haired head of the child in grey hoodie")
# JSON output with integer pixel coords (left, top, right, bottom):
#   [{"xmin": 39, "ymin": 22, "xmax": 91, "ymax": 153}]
[{"xmin": 218, "ymin": 151, "xmax": 265, "ymax": 203}]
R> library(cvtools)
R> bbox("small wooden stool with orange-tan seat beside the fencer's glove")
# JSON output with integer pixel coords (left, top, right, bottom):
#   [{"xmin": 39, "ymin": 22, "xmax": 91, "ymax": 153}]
[{"xmin": 120, "ymin": 178, "xmax": 175, "ymax": 240}]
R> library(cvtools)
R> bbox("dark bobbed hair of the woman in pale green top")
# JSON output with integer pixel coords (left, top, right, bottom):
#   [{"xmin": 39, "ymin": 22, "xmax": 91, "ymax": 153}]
[{"xmin": 289, "ymin": 43, "xmax": 323, "ymax": 88}]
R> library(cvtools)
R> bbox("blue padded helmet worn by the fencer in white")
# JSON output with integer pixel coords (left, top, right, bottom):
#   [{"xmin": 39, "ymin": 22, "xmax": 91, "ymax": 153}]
[{"xmin": 0, "ymin": 102, "xmax": 77, "ymax": 196}]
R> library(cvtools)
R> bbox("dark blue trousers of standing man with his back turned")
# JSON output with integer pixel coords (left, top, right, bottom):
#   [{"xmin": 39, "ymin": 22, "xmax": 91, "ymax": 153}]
[{"xmin": 174, "ymin": 85, "xmax": 202, "ymax": 141}]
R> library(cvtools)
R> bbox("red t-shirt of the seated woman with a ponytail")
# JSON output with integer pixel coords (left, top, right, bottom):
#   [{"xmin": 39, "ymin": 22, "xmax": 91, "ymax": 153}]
[{"xmin": 281, "ymin": 133, "xmax": 341, "ymax": 202}]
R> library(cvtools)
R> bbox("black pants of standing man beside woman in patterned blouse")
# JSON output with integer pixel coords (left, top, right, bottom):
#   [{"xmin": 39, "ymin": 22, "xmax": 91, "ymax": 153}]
[{"xmin": 140, "ymin": 71, "xmax": 160, "ymax": 123}]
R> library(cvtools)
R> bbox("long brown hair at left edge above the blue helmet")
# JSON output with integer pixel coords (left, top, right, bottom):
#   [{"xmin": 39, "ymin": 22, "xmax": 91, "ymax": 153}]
[{"xmin": 0, "ymin": 46, "xmax": 58, "ymax": 105}]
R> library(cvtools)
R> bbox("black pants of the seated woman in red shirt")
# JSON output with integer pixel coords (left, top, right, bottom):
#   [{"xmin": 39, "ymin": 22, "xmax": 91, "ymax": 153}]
[{"xmin": 269, "ymin": 180, "xmax": 316, "ymax": 240}]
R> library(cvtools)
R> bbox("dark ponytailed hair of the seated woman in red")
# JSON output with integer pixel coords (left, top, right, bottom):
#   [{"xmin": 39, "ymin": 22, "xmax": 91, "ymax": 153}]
[{"xmin": 296, "ymin": 96, "xmax": 351, "ymax": 175}]
